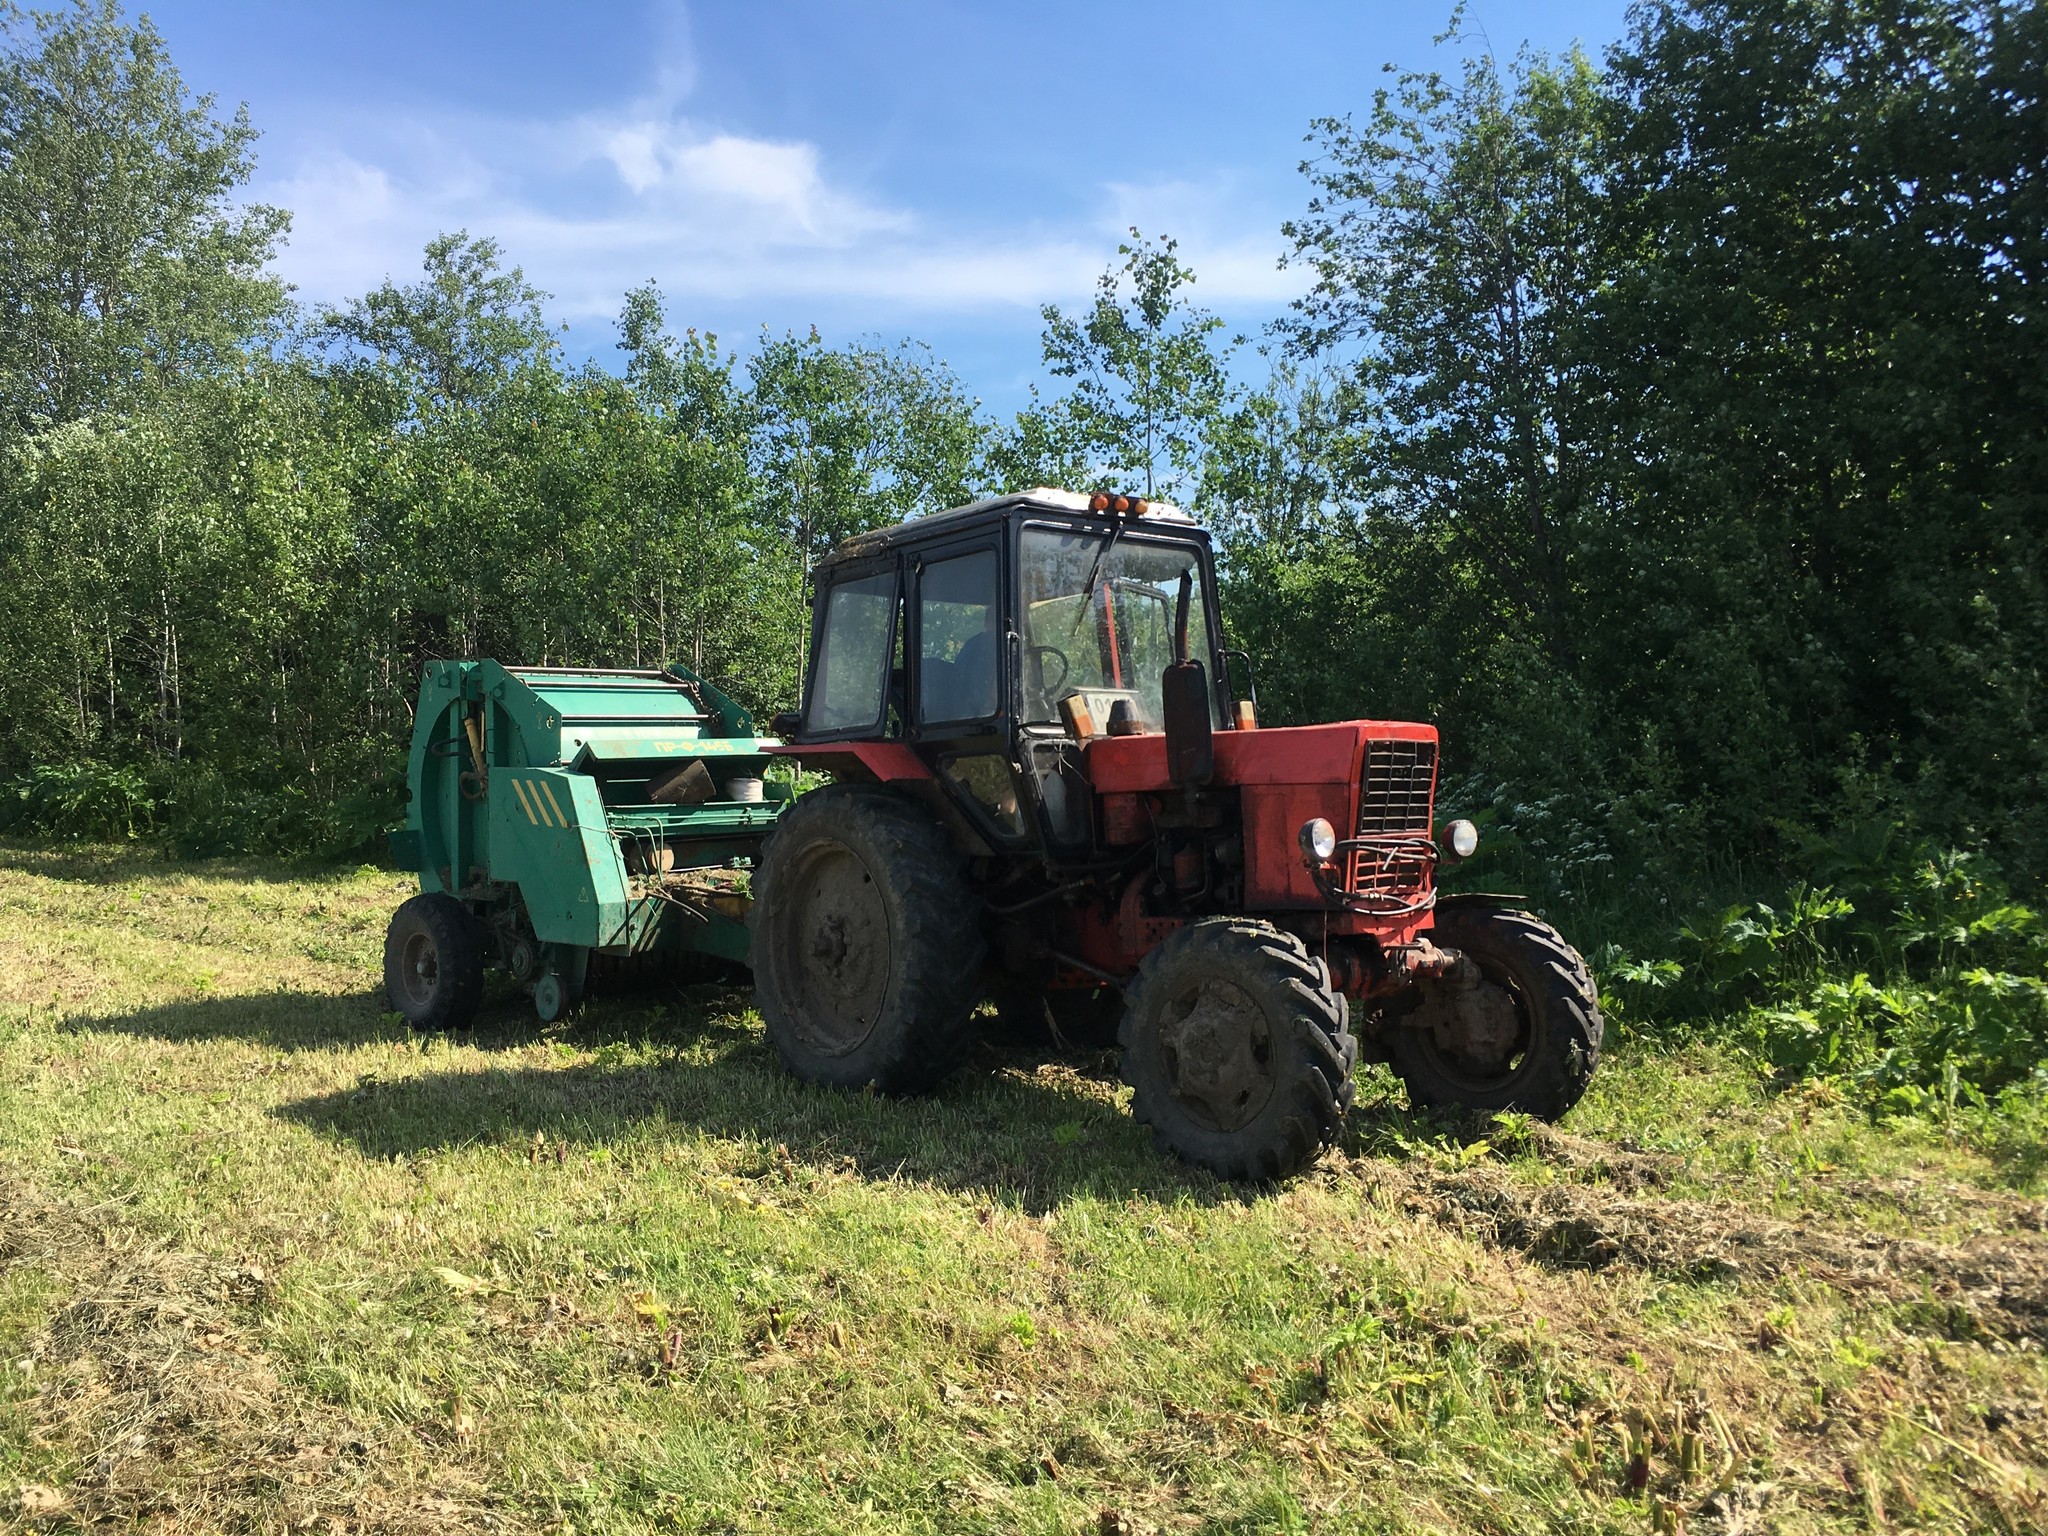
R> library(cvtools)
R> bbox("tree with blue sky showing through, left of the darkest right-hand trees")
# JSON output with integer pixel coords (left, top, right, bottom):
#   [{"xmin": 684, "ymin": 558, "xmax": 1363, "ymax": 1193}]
[{"xmin": 1282, "ymin": 34, "xmax": 1608, "ymax": 670}]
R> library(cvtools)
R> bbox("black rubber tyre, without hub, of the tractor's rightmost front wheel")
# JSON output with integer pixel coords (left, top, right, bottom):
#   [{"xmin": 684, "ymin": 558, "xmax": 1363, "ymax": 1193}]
[{"xmin": 1386, "ymin": 905, "xmax": 1606, "ymax": 1120}]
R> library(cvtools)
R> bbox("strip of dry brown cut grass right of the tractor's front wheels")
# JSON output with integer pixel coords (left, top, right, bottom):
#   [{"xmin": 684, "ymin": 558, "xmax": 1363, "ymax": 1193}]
[{"xmin": 1350, "ymin": 1153, "xmax": 2048, "ymax": 1341}]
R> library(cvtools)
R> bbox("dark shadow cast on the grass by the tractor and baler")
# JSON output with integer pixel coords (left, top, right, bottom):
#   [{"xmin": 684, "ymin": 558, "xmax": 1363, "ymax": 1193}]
[{"xmin": 70, "ymin": 983, "xmax": 1249, "ymax": 1214}]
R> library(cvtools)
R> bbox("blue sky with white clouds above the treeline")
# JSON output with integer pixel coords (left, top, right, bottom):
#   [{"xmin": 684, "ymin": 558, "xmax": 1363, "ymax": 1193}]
[{"xmin": 145, "ymin": 0, "xmax": 1624, "ymax": 410}]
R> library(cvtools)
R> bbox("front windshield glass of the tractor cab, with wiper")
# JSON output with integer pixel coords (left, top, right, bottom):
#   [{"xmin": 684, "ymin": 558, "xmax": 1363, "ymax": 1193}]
[{"xmin": 1020, "ymin": 528, "xmax": 1214, "ymax": 731}]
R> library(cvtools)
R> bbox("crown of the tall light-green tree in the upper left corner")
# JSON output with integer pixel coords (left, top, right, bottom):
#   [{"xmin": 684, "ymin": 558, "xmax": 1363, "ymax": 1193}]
[{"xmin": 0, "ymin": 0, "xmax": 289, "ymax": 432}]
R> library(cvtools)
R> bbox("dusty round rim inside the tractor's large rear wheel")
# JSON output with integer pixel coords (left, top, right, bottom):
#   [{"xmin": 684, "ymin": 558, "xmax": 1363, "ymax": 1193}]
[{"xmin": 774, "ymin": 842, "xmax": 893, "ymax": 1057}]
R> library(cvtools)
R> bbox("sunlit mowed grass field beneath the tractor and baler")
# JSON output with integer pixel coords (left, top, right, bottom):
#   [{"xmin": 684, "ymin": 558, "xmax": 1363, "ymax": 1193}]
[{"xmin": 0, "ymin": 846, "xmax": 2048, "ymax": 1536}]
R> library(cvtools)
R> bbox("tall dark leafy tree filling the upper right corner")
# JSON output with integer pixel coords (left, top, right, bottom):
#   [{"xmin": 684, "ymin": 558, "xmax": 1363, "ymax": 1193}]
[{"xmin": 1597, "ymin": 0, "xmax": 2048, "ymax": 860}]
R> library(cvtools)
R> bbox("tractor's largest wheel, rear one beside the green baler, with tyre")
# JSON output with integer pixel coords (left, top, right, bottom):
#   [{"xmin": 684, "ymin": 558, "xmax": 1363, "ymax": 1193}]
[{"xmin": 748, "ymin": 784, "xmax": 983, "ymax": 1094}]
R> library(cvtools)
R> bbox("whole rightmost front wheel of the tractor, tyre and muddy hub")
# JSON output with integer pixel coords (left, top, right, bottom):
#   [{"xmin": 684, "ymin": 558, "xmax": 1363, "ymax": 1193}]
[{"xmin": 1386, "ymin": 905, "xmax": 1604, "ymax": 1120}]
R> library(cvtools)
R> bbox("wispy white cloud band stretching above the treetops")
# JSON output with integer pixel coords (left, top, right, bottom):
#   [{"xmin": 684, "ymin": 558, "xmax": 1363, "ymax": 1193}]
[{"xmin": 256, "ymin": 29, "xmax": 1303, "ymax": 326}]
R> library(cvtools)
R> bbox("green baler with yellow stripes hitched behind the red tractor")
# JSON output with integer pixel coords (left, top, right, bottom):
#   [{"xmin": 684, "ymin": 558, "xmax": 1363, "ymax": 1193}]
[{"xmin": 385, "ymin": 662, "xmax": 784, "ymax": 1028}]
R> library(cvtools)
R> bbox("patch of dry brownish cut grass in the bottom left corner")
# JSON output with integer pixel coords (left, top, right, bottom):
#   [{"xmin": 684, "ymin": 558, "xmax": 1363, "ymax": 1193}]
[{"xmin": 0, "ymin": 1184, "xmax": 522, "ymax": 1536}]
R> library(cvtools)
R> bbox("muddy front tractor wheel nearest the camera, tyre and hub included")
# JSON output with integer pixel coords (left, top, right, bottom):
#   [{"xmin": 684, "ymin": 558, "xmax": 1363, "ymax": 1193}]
[{"xmin": 1122, "ymin": 918, "xmax": 1358, "ymax": 1182}]
